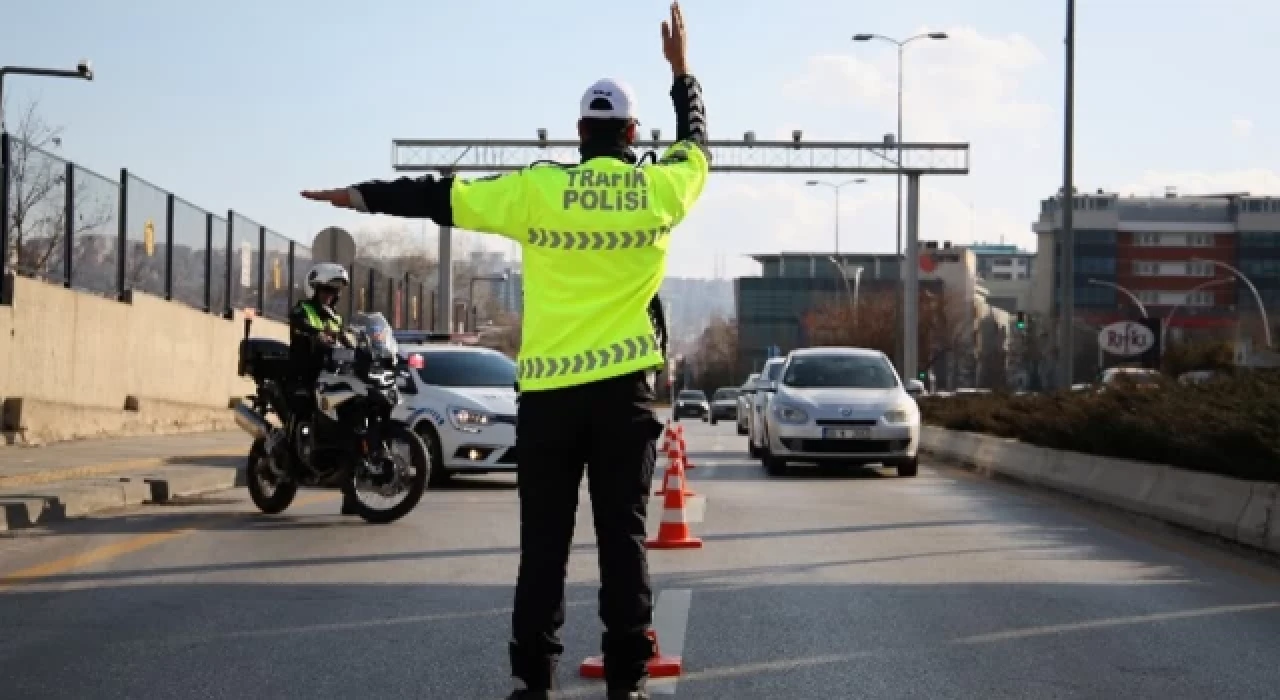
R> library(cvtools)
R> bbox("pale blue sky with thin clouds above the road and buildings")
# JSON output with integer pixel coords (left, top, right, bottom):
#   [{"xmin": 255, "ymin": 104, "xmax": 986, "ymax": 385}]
[{"xmin": 0, "ymin": 0, "xmax": 1280, "ymax": 276}]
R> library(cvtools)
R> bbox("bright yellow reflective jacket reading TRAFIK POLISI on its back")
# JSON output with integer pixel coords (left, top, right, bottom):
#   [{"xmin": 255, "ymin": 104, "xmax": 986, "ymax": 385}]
[{"xmin": 449, "ymin": 142, "xmax": 710, "ymax": 392}]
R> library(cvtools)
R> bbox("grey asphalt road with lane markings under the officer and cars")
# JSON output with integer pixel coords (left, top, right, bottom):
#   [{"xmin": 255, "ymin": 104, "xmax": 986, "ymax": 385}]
[{"xmin": 0, "ymin": 422, "xmax": 1280, "ymax": 700}]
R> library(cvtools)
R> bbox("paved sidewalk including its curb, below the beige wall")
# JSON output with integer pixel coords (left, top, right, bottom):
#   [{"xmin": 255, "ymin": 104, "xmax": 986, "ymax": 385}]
[{"xmin": 0, "ymin": 433, "xmax": 250, "ymax": 531}]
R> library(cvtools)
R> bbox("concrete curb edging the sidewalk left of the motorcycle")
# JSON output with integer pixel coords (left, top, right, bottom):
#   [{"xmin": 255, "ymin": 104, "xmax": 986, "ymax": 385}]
[{"xmin": 0, "ymin": 466, "xmax": 243, "ymax": 531}]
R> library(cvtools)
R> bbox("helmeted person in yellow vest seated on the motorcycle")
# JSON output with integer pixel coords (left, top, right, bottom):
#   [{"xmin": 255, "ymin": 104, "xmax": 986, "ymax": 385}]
[{"xmin": 289, "ymin": 262, "xmax": 355, "ymax": 516}]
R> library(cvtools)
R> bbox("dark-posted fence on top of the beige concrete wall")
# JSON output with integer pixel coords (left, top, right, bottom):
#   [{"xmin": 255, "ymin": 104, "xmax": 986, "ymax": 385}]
[{"xmin": 0, "ymin": 134, "xmax": 435, "ymax": 330}]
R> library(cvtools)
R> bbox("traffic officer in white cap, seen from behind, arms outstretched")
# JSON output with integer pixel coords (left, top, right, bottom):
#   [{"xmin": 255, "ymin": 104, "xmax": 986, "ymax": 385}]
[{"xmin": 302, "ymin": 4, "xmax": 710, "ymax": 700}]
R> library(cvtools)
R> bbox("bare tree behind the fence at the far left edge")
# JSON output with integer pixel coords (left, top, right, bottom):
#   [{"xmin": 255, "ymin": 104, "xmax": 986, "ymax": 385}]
[{"xmin": 5, "ymin": 102, "xmax": 115, "ymax": 282}]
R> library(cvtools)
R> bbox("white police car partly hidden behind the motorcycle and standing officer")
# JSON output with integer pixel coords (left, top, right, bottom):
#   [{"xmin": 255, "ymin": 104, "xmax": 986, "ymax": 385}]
[{"xmin": 396, "ymin": 333, "xmax": 516, "ymax": 484}]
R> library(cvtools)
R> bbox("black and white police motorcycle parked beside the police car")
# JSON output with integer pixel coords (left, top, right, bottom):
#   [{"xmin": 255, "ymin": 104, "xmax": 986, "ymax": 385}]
[{"xmin": 236, "ymin": 314, "xmax": 431, "ymax": 523}]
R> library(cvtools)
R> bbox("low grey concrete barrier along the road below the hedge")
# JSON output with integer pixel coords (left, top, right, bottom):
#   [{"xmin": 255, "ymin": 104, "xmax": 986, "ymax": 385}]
[{"xmin": 920, "ymin": 425, "xmax": 1280, "ymax": 554}]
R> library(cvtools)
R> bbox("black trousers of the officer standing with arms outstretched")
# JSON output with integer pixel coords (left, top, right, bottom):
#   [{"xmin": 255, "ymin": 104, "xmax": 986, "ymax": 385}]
[{"xmin": 511, "ymin": 372, "xmax": 662, "ymax": 690}]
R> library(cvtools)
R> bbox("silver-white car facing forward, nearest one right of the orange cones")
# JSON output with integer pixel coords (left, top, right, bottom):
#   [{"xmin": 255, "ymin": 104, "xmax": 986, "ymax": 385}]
[{"xmin": 759, "ymin": 348, "xmax": 924, "ymax": 476}]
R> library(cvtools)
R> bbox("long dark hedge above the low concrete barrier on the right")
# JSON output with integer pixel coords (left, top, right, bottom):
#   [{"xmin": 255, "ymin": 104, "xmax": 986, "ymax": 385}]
[{"xmin": 920, "ymin": 372, "xmax": 1280, "ymax": 481}]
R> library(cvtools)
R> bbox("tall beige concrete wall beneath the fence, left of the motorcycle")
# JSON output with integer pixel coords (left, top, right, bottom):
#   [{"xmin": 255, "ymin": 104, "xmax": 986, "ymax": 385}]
[{"xmin": 0, "ymin": 278, "xmax": 288, "ymax": 443}]
